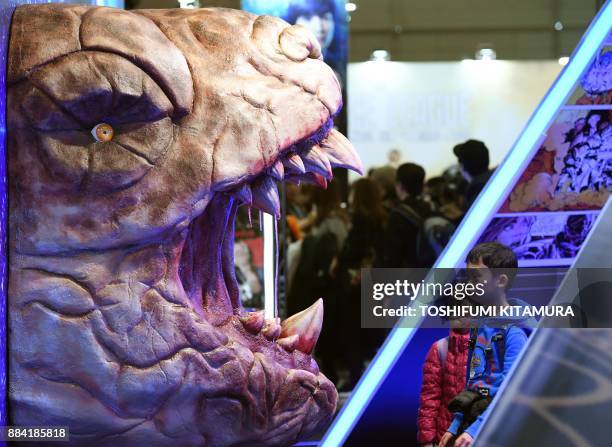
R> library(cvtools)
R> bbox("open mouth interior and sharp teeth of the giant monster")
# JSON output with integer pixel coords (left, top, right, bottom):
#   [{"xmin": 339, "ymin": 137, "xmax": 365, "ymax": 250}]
[{"xmin": 178, "ymin": 124, "xmax": 363, "ymax": 354}]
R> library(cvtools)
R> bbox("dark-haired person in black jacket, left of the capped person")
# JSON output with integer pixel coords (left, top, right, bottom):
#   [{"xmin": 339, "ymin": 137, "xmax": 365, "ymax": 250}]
[{"xmin": 382, "ymin": 163, "xmax": 433, "ymax": 268}]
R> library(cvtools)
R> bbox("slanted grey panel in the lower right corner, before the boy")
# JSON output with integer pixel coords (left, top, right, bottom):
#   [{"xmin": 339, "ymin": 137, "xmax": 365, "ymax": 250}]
[{"xmin": 478, "ymin": 200, "xmax": 612, "ymax": 446}]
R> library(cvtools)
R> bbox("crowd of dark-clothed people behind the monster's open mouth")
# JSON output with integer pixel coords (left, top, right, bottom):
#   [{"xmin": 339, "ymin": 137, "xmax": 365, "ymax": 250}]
[{"xmin": 284, "ymin": 140, "xmax": 491, "ymax": 390}]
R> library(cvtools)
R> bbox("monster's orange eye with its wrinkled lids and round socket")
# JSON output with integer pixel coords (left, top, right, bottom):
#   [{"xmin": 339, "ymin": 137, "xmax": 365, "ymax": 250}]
[{"xmin": 19, "ymin": 50, "xmax": 174, "ymax": 194}]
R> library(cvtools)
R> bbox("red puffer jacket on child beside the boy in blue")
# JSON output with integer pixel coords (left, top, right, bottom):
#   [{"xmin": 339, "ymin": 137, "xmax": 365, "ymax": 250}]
[{"xmin": 417, "ymin": 329, "xmax": 470, "ymax": 444}]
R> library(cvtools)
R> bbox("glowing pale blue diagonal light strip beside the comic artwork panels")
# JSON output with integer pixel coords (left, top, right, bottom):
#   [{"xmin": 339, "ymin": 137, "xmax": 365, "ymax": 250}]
[{"xmin": 321, "ymin": 0, "xmax": 612, "ymax": 447}]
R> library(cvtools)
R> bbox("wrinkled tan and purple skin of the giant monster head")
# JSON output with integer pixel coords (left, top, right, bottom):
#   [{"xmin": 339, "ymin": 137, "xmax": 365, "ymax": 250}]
[{"xmin": 8, "ymin": 4, "xmax": 359, "ymax": 447}]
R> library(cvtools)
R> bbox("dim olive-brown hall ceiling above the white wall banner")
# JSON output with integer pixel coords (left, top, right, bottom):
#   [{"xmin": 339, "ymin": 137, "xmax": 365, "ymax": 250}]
[{"xmin": 126, "ymin": 0, "xmax": 604, "ymax": 62}]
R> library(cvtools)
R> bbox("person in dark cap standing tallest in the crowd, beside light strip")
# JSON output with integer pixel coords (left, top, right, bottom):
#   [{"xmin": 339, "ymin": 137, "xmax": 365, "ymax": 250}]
[{"xmin": 453, "ymin": 140, "xmax": 493, "ymax": 208}]
